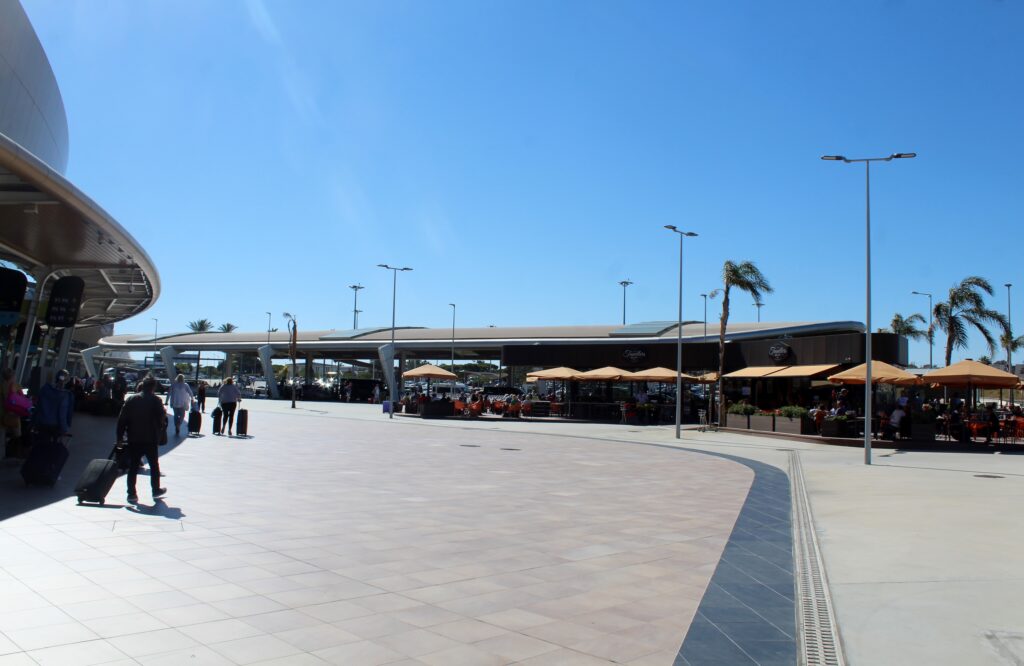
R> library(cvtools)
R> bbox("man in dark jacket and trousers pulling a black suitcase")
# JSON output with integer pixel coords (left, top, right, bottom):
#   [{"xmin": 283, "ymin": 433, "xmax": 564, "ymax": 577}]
[{"xmin": 118, "ymin": 377, "xmax": 167, "ymax": 502}]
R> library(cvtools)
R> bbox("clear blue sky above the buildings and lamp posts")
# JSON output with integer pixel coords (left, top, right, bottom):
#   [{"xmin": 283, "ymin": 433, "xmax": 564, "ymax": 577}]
[{"xmin": 23, "ymin": 0, "xmax": 1024, "ymax": 363}]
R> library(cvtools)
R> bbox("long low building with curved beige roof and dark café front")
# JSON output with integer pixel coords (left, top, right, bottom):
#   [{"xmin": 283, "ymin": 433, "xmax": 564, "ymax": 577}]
[{"xmin": 97, "ymin": 322, "xmax": 907, "ymax": 399}]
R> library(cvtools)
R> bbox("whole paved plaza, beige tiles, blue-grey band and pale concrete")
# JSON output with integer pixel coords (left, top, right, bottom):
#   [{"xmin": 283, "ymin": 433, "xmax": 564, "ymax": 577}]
[{"xmin": 0, "ymin": 401, "xmax": 1024, "ymax": 666}]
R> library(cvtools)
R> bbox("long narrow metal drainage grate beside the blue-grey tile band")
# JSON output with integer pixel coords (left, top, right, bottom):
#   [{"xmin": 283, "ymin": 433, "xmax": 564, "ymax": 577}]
[{"xmin": 790, "ymin": 451, "xmax": 846, "ymax": 666}]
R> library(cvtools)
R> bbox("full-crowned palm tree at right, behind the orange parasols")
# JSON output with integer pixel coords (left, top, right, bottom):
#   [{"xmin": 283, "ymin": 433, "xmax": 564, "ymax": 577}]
[{"xmin": 932, "ymin": 276, "xmax": 1010, "ymax": 366}]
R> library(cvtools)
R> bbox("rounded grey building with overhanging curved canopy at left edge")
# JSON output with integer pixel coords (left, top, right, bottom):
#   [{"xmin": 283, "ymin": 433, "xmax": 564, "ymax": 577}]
[{"xmin": 0, "ymin": 1, "xmax": 160, "ymax": 384}]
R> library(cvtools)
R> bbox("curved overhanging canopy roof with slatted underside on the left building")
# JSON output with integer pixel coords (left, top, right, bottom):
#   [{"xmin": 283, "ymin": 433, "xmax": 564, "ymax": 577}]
[{"xmin": 0, "ymin": 134, "xmax": 160, "ymax": 326}]
